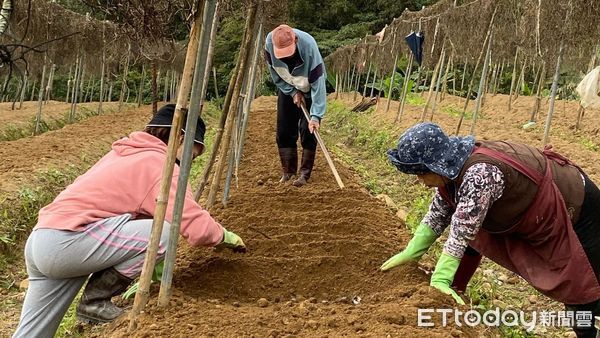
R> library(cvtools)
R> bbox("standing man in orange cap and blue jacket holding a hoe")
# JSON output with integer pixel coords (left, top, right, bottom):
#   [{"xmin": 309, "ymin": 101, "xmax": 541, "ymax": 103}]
[{"xmin": 265, "ymin": 25, "xmax": 327, "ymax": 187}]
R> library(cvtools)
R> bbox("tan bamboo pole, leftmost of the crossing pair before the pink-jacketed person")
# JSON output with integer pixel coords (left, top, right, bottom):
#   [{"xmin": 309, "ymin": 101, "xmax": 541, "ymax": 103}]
[{"xmin": 128, "ymin": 4, "xmax": 201, "ymax": 333}]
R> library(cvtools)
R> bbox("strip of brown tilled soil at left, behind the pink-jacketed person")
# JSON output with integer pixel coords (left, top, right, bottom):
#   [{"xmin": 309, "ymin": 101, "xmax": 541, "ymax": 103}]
[{"xmin": 0, "ymin": 104, "xmax": 152, "ymax": 196}]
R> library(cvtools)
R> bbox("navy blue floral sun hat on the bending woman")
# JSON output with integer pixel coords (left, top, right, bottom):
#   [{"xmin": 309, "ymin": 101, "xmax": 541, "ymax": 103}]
[{"xmin": 387, "ymin": 122, "xmax": 475, "ymax": 180}]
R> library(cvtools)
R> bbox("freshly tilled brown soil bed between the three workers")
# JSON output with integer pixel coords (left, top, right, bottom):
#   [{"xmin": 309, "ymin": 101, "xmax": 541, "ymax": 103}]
[{"xmin": 99, "ymin": 97, "xmax": 478, "ymax": 337}]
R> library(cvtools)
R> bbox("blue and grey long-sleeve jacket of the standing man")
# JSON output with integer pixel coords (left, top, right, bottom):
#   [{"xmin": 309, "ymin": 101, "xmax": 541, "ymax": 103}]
[{"xmin": 265, "ymin": 29, "xmax": 327, "ymax": 121}]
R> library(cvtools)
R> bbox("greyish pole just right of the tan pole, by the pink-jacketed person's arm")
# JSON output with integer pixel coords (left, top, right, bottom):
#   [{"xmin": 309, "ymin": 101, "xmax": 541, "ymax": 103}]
[{"xmin": 158, "ymin": 0, "xmax": 218, "ymax": 306}]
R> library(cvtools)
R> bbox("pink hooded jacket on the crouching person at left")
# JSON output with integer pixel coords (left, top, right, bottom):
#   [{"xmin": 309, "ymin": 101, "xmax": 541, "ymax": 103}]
[{"xmin": 35, "ymin": 132, "xmax": 223, "ymax": 246}]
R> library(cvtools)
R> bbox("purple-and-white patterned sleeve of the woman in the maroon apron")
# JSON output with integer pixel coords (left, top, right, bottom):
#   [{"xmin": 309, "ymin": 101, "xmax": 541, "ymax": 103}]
[{"xmin": 444, "ymin": 163, "xmax": 504, "ymax": 258}]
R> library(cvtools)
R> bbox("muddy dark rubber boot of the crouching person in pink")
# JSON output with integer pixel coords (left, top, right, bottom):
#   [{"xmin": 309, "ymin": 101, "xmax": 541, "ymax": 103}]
[{"xmin": 76, "ymin": 267, "xmax": 132, "ymax": 323}]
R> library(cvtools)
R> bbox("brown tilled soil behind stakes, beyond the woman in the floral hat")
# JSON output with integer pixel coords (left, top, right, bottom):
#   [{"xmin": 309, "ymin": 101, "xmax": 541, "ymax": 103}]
[{"xmin": 340, "ymin": 93, "xmax": 600, "ymax": 183}]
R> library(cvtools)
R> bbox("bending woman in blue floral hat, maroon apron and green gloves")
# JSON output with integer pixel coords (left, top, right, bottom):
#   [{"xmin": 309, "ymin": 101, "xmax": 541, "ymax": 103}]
[{"xmin": 381, "ymin": 123, "xmax": 600, "ymax": 337}]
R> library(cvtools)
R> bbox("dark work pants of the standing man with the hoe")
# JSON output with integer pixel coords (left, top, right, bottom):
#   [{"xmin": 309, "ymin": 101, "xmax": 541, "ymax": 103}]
[{"xmin": 276, "ymin": 90, "xmax": 317, "ymax": 151}]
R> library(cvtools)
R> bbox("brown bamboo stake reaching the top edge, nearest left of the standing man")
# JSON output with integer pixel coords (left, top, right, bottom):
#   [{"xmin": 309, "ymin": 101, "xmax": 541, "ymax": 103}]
[{"xmin": 206, "ymin": 2, "xmax": 257, "ymax": 209}]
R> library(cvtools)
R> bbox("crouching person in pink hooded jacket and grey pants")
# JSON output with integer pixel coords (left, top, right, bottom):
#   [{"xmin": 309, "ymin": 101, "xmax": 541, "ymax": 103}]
[{"xmin": 14, "ymin": 104, "xmax": 246, "ymax": 337}]
